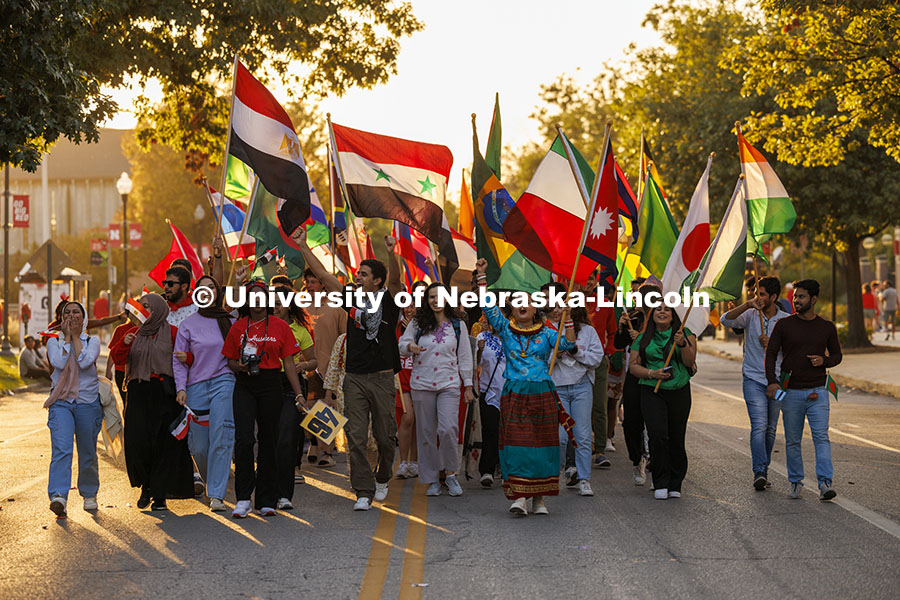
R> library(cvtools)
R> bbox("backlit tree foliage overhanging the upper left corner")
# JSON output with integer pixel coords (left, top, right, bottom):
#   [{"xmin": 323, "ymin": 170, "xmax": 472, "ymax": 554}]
[{"xmin": 0, "ymin": 0, "xmax": 422, "ymax": 170}]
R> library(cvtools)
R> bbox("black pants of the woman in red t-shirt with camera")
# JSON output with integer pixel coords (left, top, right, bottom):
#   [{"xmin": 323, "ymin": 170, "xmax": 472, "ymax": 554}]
[{"xmin": 234, "ymin": 369, "xmax": 284, "ymax": 509}]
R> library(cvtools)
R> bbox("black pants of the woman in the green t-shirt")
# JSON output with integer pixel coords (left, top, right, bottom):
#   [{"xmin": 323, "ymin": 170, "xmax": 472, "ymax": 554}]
[{"xmin": 640, "ymin": 384, "xmax": 691, "ymax": 492}]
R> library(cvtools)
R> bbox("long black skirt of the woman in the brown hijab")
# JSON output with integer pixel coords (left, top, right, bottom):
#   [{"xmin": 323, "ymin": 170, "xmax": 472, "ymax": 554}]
[{"xmin": 125, "ymin": 379, "xmax": 194, "ymax": 500}]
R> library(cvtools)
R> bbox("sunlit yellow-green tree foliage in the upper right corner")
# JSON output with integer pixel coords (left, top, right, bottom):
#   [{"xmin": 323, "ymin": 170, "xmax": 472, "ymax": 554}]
[{"xmin": 726, "ymin": 0, "xmax": 900, "ymax": 166}]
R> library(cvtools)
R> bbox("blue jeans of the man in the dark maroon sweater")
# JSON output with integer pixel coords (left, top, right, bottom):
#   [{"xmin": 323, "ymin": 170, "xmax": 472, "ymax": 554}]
[{"xmin": 781, "ymin": 387, "xmax": 834, "ymax": 485}]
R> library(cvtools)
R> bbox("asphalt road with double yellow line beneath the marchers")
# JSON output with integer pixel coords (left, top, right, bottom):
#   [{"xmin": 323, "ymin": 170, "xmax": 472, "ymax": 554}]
[{"xmin": 0, "ymin": 355, "xmax": 900, "ymax": 599}]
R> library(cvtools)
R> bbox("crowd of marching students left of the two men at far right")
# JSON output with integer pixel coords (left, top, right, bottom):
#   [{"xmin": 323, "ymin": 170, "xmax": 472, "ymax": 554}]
[{"xmin": 40, "ymin": 228, "xmax": 696, "ymax": 517}]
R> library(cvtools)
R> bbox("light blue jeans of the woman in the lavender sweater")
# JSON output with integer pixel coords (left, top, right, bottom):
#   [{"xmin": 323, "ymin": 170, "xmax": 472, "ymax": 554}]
[{"xmin": 185, "ymin": 373, "xmax": 234, "ymax": 500}]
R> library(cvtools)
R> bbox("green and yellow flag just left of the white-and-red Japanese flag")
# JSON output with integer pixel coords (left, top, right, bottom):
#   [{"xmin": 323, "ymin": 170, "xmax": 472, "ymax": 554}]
[{"xmin": 629, "ymin": 174, "xmax": 678, "ymax": 279}]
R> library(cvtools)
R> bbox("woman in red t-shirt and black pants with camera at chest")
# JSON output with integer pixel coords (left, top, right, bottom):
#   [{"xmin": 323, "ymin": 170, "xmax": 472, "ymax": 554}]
[{"xmin": 222, "ymin": 281, "xmax": 304, "ymax": 518}]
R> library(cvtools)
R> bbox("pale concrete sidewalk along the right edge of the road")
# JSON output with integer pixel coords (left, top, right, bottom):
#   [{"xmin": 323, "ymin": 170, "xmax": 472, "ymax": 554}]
[{"xmin": 698, "ymin": 334, "xmax": 900, "ymax": 398}]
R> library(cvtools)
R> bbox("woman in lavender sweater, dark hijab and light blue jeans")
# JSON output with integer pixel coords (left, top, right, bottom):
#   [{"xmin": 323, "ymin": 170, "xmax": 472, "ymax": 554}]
[{"xmin": 172, "ymin": 275, "xmax": 236, "ymax": 512}]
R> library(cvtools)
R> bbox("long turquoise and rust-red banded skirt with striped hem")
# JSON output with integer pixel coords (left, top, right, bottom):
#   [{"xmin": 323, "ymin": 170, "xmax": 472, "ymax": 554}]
[{"xmin": 497, "ymin": 380, "xmax": 574, "ymax": 499}]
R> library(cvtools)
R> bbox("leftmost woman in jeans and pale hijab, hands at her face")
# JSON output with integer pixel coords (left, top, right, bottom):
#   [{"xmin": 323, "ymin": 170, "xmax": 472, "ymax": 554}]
[{"xmin": 44, "ymin": 302, "xmax": 103, "ymax": 517}]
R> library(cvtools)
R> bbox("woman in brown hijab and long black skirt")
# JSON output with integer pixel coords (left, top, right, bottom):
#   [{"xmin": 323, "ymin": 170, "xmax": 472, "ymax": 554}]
[{"xmin": 125, "ymin": 294, "xmax": 194, "ymax": 510}]
